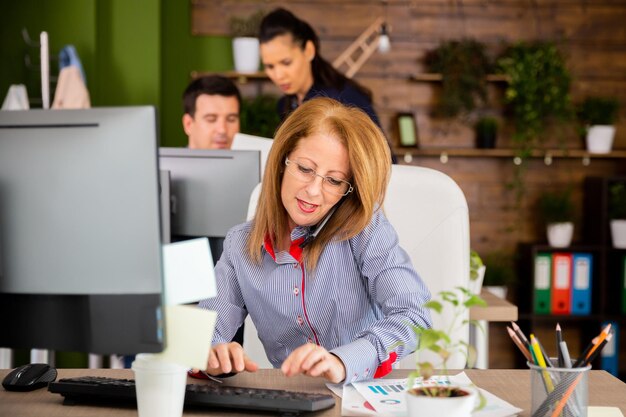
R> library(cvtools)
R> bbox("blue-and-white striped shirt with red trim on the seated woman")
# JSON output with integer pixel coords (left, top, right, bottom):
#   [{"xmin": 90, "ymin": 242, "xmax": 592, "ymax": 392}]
[{"xmin": 200, "ymin": 211, "xmax": 431, "ymax": 383}]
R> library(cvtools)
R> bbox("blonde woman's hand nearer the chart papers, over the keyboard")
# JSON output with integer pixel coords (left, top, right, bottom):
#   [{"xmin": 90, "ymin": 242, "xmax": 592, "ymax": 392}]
[{"xmin": 280, "ymin": 343, "xmax": 346, "ymax": 384}]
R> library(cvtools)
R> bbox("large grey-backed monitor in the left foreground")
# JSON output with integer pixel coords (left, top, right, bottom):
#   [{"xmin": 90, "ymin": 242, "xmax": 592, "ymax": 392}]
[{"xmin": 0, "ymin": 107, "xmax": 163, "ymax": 354}]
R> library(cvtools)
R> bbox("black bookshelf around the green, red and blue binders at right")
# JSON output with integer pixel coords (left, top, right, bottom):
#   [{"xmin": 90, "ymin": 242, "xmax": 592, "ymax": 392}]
[{"xmin": 517, "ymin": 177, "xmax": 626, "ymax": 380}]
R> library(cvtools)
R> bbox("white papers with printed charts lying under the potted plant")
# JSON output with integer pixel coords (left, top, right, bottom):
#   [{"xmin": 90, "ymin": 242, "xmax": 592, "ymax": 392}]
[{"xmin": 327, "ymin": 372, "xmax": 522, "ymax": 417}]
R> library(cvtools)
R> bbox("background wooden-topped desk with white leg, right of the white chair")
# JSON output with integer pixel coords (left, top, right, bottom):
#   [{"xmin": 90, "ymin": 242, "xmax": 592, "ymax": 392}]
[{"xmin": 470, "ymin": 289, "xmax": 517, "ymax": 369}]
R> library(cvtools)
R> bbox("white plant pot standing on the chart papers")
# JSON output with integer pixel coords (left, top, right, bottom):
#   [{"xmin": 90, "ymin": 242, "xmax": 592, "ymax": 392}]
[{"xmin": 406, "ymin": 387, "xmax": 476, "ymax": 417}]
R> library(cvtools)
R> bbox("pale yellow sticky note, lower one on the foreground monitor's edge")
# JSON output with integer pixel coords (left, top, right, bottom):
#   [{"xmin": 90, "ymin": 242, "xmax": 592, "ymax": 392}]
[{"xmin": 157, "ymin": 305, "xmax": 217, "ymax": 369}]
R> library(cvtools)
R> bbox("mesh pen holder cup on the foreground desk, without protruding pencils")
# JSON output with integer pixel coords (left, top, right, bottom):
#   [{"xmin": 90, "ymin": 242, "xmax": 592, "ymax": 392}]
[{"xmin": 528, "ymin": 362, "xmax": 591, "ymax": 417}]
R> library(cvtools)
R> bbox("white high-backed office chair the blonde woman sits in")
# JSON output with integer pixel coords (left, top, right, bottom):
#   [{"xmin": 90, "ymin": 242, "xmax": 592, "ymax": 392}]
[{"xmin": 244, "ymin": 165, "xmax": 469, "ymax": 369}]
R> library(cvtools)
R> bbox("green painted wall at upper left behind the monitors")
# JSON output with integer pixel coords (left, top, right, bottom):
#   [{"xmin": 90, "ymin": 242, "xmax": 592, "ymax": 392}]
[{"xmin": 0, "ymin": 0, "xmax": 232, "ymax": 146}]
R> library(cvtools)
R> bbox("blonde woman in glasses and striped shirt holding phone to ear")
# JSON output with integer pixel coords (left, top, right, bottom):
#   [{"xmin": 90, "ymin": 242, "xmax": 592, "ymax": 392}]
[{"xmin": 200, "ymin": 98, "xmax": 431, "ymax": 383}]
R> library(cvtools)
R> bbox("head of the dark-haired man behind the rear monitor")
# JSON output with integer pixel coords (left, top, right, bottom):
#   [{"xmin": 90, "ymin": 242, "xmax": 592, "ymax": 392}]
[{"xmin": 183, "ymin": 75, "xmax": 241, "ymax": 149}]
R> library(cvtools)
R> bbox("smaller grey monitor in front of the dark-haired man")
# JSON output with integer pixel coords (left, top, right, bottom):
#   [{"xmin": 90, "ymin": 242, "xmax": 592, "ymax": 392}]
[{"xmin": 159, "ymin": 148, "xmax": 261, "ymax": 239}]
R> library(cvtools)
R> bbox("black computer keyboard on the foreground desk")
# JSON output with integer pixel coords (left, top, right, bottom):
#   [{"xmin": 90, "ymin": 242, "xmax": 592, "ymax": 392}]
[{"xmin": 48, "ymin": 376, "xmax": 335, "ymax": 414}]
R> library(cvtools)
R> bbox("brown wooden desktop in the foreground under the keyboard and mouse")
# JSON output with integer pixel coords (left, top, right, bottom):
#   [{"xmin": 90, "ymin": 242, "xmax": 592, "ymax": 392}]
[{"xmin": 0, "ymin": 369, "xmax": 626, "ymax": 417}]
